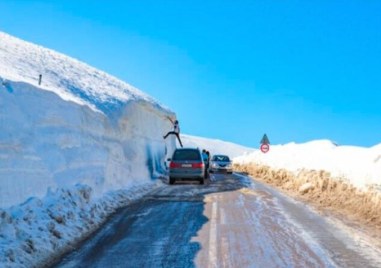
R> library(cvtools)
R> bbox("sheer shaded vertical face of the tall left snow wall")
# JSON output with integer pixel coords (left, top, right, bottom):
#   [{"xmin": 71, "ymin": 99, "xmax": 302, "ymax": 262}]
[{"xmin": 0, "ymin": 78, "xmax": 176, "ymax": 208}]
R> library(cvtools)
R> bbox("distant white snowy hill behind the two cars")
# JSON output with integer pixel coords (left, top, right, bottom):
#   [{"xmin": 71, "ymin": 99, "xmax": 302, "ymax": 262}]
[{"xmin": 181, "ymin": 135, "xmax": 254, "ymax": 158}]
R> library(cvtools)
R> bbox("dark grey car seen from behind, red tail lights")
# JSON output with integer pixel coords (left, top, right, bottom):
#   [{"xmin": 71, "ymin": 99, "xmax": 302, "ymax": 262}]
[{"xmin": 168, "ymin": 148, "xmax": 205, "ymax": 184}]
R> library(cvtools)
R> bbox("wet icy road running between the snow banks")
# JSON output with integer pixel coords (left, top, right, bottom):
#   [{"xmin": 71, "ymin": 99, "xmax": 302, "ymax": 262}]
[{"xmin": 56, "ymin": 175, "xmax": 381, "ymax": 268}]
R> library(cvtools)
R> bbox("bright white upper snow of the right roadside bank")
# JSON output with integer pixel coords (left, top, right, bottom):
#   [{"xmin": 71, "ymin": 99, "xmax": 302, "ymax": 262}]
[{"xmin": 234, "ymin": 140, "xmax": 381, "ymax": 188}]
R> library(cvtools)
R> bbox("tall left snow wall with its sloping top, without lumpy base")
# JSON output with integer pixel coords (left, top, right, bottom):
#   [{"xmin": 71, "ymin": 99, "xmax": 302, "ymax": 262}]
[{"xmin": 0, "ymin": 32, "xmax": 175, "ymax": 208}]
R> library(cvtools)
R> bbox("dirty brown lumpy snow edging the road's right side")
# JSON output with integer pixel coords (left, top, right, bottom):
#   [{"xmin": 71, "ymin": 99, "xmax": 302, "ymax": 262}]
[{"xmin": 235, "ymin": 164, "xmax": 381, "ymax": 228}]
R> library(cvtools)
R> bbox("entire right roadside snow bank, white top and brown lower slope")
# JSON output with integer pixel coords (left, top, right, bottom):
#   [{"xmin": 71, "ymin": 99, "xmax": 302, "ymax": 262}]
[{"xmin": 234, "ymin": 140, "xmax": 381, "ymax": 233}]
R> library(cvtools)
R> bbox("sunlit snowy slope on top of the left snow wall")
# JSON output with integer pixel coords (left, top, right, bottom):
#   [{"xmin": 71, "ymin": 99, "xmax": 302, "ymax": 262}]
[{"xmin": 0, "ymin": 32, "xmax": 169, "ymax": 114}]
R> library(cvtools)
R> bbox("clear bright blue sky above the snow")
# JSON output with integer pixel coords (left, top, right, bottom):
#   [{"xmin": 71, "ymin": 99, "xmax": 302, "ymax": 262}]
[{"xmin": 0, "ymin": 0, "xmax": 381, "ymax": 147}]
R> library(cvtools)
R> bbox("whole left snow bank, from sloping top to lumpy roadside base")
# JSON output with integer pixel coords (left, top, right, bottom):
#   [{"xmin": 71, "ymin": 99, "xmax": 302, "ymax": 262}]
[{"xmin": 0, "ymin": 32, "xmax": 176, "ymax": 267}]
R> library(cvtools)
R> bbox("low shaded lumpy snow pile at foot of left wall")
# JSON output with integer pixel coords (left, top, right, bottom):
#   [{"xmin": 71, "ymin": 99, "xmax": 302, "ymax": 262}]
[{"xmin": 0, "ymin": 183, "xmax": 160, "ymax": 267}]
